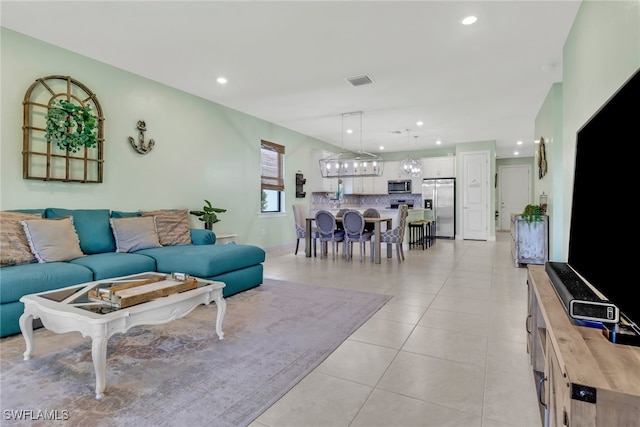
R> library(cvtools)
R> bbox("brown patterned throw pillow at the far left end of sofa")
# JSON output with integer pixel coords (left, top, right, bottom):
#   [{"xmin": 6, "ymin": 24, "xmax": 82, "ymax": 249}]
[{"xmin": 0, "ymin": 211, "xmax": 42, "ymax": 267}]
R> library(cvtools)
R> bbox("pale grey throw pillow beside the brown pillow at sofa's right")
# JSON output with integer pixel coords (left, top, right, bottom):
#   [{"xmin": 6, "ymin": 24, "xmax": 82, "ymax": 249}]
[{"xmin": 111, "ymin": 216, "xmax": 162, "ymax": 252}]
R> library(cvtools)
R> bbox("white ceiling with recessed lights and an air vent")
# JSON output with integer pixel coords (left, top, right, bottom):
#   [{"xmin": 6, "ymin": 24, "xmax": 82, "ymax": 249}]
[{"xmin": 0, "ymin": 0, "xmax": 580, "ymax": 158}]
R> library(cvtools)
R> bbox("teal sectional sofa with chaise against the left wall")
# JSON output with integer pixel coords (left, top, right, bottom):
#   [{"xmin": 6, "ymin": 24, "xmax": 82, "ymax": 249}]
[{"xmin": 0, "ymin": 208, "xmax": 265, "ymax": 337}]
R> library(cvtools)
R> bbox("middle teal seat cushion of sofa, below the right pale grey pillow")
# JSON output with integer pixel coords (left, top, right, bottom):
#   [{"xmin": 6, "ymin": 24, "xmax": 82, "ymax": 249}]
[{"xmin": 70, "ymin": 252, "xmax": 156, "ymax": 280}]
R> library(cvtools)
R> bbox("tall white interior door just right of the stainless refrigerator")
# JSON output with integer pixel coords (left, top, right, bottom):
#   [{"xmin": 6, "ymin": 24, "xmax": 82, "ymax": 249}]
[{"xmin": 462, "ymin": 151, "xmax": 489, "ymax": 240}]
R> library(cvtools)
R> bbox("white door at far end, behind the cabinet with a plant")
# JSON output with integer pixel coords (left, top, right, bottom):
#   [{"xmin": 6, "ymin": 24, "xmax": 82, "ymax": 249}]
[{"xmin": 498, "ymin": 165, "xmax": 531, "ymax": 230}]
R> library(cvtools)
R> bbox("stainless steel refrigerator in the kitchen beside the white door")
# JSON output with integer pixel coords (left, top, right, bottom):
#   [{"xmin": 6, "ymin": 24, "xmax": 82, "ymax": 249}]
[{"xmin": 422, "ymin": 178, "xmax": 456, "ymax": 239}]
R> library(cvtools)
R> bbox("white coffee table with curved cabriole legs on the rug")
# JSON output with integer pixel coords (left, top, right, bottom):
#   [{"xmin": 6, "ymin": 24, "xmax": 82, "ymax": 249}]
[{"xmin": 20, "ymin": 272, "xmax": 227, "ymax": 399}]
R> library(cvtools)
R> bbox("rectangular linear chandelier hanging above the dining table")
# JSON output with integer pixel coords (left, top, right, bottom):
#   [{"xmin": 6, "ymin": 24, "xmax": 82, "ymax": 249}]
[{"xmin": 319, "ymin": 111, "xmax": 384, "ymax": 178}]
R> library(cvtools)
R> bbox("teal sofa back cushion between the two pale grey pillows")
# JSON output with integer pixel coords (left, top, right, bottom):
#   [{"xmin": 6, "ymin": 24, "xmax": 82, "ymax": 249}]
[{"xmin": 44, "ymin": 208, "xmax": 116, "ymax": 254}]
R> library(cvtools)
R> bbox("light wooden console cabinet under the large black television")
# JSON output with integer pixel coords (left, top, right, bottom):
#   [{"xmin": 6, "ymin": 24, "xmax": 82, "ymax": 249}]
[{"xmin": 527, "ymin": 265, "xmax": 640, "ymax": 427}]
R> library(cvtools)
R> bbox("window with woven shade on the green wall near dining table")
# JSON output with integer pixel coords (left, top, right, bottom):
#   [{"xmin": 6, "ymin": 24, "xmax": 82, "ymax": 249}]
[{"xmin": 260, "ymin": 140, "xmax": 284, "ymax": 212}]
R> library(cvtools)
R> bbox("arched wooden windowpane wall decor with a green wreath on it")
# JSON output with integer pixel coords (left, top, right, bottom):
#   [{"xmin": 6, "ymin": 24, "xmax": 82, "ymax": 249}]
[{"xmin": 22, "ymin": 76, "xmax": 104, "ymax": 183}]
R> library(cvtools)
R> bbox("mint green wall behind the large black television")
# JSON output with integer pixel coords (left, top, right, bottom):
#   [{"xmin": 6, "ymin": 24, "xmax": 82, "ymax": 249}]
[{"xmin": 536, "ymin": 0, "xmax": 640, "ymax": 261}]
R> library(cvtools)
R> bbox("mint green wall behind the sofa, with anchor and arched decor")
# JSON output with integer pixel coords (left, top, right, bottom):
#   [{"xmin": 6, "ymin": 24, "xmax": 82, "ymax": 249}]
[{"xmin": 0, "ymin": 28, "xmax": 336, "ymax": 247}]
